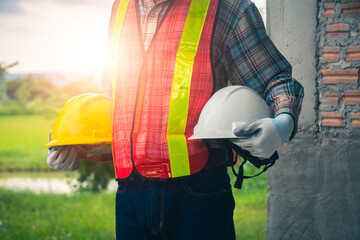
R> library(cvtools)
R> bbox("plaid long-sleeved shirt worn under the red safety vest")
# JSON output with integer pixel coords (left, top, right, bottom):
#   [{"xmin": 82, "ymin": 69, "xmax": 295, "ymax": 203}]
[{"xmin": 103, "ymin": 0, "xmax": 304, "ymax": 138}]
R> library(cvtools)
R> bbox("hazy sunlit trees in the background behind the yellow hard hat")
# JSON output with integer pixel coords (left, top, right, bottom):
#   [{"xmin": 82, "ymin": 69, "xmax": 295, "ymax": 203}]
[{"xmin": 0, "ymin": 75, "xmax": 100, "ymax": 116}]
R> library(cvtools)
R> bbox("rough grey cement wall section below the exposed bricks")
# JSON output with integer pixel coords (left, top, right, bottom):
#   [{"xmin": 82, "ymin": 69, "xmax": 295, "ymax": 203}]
[{"xmin": 267, "ymin": 134, "xmax": 360, "ymax": 240}]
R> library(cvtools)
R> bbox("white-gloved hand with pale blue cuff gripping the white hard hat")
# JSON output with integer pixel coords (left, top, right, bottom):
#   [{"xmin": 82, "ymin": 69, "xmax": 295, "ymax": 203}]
[{"xmin": 230, "ymin": 113, "xmax": 294, "ymax": 158}]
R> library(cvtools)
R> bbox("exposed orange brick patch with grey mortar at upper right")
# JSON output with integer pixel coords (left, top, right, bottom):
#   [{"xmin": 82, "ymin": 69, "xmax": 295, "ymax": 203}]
[{"xmin": 317, "ymin": 0, "xmax": 360, "ymax": 136}]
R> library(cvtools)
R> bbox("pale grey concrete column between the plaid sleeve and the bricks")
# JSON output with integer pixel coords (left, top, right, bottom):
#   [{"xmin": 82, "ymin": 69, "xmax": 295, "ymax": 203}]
[{"xmin": 266, "ymin": 0, "xmax": 317, "ymax": 131}]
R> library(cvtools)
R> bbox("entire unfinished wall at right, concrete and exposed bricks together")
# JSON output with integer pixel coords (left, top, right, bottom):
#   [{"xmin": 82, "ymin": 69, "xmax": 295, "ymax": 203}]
[{"xmin": 267, "ymin": 0, "xmax": 360, "ymax": 240}]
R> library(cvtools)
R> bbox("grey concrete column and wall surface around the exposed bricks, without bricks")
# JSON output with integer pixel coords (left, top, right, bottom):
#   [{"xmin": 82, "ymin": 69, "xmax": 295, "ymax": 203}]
[{"xmin": 267, "ymin": 0, "xmax": 360, "ymax": 240}]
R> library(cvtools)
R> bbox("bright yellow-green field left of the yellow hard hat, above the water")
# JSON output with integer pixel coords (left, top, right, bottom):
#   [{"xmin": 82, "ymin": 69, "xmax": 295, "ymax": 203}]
[{"xmin": 0, "ymin": 115, "xmax": 55, "ymax": 171}]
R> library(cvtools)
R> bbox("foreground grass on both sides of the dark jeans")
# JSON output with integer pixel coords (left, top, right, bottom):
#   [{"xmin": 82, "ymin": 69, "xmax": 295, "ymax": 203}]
[{"xmin": 0, "ymin": 180, "xmax": 266, "ymax": 240}]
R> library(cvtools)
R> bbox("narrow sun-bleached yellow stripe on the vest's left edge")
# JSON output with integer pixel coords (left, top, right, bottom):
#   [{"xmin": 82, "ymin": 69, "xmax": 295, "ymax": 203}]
[{"xmin": 112, "ymin": 0, "xmax": 129, "ymax": 100}]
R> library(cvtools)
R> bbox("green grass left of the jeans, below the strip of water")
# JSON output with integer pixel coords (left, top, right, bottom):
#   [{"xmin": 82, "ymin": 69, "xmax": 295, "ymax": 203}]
[{"xmin": 0, "ymin": 189, "xmax": 115, "ymax": 240}]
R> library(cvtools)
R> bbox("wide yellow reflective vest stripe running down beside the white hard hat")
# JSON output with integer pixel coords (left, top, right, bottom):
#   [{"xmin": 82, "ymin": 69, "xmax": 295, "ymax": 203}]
[{"xmin": 167, "ymin": 0, "xmax": 210, "ymax": 178}]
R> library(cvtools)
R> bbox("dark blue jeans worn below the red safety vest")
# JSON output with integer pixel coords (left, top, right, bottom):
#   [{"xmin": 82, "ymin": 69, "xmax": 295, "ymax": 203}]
[{"xmin": 116, "ymin": 167, "xmax": 235, "ymax": 240}]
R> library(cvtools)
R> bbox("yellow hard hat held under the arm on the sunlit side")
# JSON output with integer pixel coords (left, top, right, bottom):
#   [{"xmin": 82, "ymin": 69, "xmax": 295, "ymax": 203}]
[{"xmin": 45, "ymin": 93, "xmax": 112, "ymax": 147}]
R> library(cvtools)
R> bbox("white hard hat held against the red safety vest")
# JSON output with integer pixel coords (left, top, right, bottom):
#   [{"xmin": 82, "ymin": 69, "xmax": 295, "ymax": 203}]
[{"xmin": 189, "ymin": 86, "xmax": 273, "ymax": 140}]
